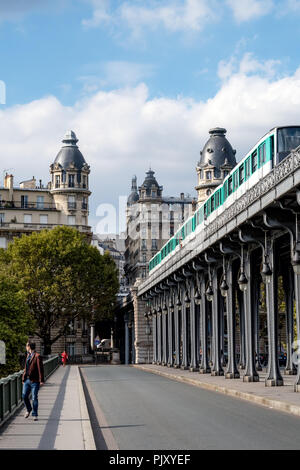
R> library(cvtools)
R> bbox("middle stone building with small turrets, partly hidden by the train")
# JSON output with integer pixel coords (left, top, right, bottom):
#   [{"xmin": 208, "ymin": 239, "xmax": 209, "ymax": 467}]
[{"xmin": 125, "ymin": 169, "xmax": 196, "ymax": 286}]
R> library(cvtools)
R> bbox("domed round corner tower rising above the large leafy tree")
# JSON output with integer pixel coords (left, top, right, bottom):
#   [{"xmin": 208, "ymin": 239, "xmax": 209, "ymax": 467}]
[{"xmin": 50, "ymin": 131, "xmax": 91, "ymax": 230}]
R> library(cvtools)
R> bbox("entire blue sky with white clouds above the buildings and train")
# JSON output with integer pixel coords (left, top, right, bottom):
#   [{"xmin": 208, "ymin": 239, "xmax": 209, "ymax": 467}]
[{"xmin": 0, "ymin": 0, "xmax": 300, "ymax": 232}]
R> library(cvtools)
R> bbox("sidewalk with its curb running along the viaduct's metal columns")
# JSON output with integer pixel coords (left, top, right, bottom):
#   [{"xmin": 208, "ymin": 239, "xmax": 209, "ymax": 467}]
[{"xmin": 132, "ymin": 364, "xmax": 300, "ymax": 416}]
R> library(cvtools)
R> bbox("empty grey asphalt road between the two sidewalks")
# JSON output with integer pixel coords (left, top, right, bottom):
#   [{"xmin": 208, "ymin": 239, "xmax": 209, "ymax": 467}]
[{"xmin": 83, "ymin": 366, "xmax": 300, "ymax": 450}]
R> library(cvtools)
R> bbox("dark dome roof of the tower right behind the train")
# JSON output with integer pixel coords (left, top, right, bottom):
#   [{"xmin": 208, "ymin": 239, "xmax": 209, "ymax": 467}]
[{"xmin": 199, "ymin": 127, "xmax": 236, "ymax": 169}]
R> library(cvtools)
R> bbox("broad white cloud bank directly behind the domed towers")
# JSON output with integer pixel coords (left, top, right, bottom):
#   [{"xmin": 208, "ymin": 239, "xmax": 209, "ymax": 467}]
[{"xmin": 0, "ymin": 55, "xmax": 300, "ymax": 233}]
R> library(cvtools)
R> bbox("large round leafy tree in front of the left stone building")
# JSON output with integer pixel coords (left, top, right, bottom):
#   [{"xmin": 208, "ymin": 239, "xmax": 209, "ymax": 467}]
[{"xmin": 6, "ymin": 226, "xmax": 119, "ymax": 354}]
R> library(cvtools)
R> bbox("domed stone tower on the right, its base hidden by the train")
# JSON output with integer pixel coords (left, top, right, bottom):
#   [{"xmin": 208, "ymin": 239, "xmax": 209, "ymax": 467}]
[{"xmin": 195, "ymin": 127, "xmax": 236, "ymax": 204}]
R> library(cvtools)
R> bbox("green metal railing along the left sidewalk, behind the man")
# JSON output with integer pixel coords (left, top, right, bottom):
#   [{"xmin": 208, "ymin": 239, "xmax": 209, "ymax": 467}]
[{"xmin": 0, "ymin": 355, "xmax": 60, "ymax": 426}]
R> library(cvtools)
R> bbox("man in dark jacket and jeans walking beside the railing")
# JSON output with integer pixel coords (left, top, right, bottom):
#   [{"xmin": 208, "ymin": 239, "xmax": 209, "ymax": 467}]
[{"xmin": 22, "ymin": 341, "xmax": 44, "ymax": 421}]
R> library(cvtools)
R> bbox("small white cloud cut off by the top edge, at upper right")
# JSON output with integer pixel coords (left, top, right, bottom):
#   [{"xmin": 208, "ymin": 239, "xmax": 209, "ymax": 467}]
[{"xmin": 226, "ymin": 0, "xmax": 274, "ymax": 23}]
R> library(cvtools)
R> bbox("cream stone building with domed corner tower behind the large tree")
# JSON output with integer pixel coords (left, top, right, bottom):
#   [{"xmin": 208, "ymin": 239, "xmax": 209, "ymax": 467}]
[{"xmin": 0, "ymin": 131, "xmax": 92, "ymax": 355}]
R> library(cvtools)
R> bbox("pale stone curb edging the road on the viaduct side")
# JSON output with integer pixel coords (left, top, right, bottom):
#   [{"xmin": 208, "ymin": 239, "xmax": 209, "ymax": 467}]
[{"xmin": 132, "ymin": 364, "xmax": 300, "ymax": 417}]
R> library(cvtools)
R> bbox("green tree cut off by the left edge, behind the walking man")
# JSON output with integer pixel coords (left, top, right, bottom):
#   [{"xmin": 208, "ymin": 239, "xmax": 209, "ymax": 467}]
[{"xmin": 0, "ymin": 273, "xmax": 35, "ymax": 377}]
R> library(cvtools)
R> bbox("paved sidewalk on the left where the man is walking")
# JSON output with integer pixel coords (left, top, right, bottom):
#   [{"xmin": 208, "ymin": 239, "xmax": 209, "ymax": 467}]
[{"xmin": 0, "ymin": 366, "xmax": 95, "ymax": 450}]
